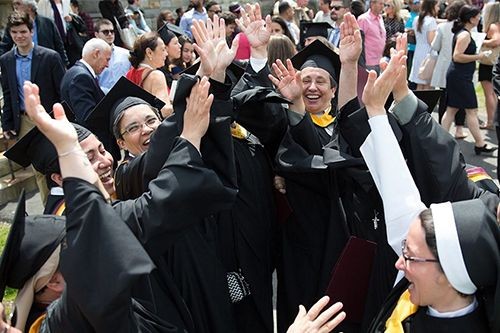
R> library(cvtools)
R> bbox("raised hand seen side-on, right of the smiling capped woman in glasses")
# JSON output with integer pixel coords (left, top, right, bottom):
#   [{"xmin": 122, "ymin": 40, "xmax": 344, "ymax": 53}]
[{"xmin": 181, "ymin": 77, "xmax": 214, "ymax": 151}]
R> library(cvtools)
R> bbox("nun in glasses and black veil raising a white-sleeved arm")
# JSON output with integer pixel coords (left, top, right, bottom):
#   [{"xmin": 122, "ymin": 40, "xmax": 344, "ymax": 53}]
[{"xmin": 361, "ymin": 51, "xmax": 500, "ymax": 333}]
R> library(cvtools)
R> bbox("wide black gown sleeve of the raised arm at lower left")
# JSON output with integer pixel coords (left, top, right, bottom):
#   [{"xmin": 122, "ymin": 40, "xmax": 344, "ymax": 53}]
[{"xmin": 44, "ymin": 178, "xmax": 154, "ymax": 332}]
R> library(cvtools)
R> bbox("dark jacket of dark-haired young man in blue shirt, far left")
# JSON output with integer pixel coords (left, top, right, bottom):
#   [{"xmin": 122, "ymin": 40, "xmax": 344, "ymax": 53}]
[{"xmin": 0, "ymin": 46, "xmax": 65, "ymax": 131}]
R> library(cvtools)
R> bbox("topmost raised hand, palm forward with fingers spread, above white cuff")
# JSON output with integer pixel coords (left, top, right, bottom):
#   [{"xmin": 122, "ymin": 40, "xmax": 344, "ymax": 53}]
[{"xmin": 236, "ymin": 3, "xmax": 271, "ymax": 48}]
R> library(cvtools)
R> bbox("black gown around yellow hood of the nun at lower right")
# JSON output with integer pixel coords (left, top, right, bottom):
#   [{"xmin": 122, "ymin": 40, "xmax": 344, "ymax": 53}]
[{"xmin": 367, "ymin": 279, "xmax": 490, "ymax": 333}]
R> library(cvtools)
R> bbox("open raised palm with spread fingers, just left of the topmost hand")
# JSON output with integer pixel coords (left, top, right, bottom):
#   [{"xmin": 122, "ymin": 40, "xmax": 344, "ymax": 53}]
[{"xmin": 192, "ymin": 15, "xmax": 239, "ymax": 76}]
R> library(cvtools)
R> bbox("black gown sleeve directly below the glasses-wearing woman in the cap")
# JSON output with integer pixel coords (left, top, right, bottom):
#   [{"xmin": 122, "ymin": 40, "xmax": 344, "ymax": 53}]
[{"xmin": 114, "ymin": 138, "xmax": 237, "ymax": 259}]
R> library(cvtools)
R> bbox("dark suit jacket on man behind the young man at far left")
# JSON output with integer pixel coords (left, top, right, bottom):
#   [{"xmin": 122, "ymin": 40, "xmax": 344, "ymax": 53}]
[{"xmin": 0, "ymin": 15, "xmax": 69, "ymax": 66}]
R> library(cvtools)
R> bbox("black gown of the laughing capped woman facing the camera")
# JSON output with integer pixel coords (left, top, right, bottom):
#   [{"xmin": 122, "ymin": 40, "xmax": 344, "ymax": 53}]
[{"xmin": 277, "ymin": 100, "xmax": 368, "ymax": 332}]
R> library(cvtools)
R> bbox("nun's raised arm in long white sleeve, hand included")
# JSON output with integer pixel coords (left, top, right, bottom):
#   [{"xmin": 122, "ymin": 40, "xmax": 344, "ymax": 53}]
[{"xmin": 361, "ymin": 51, "xmax": 425, "ymax": 254}]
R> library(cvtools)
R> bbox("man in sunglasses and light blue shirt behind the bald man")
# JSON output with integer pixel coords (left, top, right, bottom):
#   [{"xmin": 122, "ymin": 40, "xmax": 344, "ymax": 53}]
[{"xmin": 95, "ymin": 19, "xmax": 131, "ymax": 94}]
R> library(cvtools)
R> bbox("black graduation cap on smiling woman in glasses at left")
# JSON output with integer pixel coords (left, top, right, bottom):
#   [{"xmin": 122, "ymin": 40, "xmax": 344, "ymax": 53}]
[{"xmin": 85, "ymin": 76, "xmax": 165, "ymax": 138}]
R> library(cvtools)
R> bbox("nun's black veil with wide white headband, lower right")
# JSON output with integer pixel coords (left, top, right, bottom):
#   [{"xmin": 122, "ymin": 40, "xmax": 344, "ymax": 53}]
[{"xmin": 430, "ymin": 199, "xmax": 500, "ymax": 332}]
